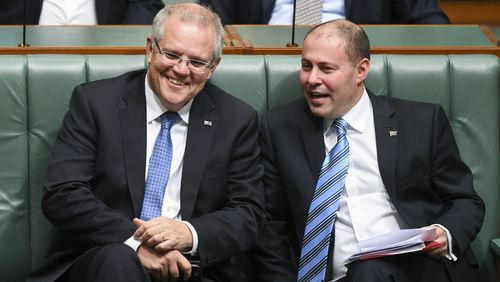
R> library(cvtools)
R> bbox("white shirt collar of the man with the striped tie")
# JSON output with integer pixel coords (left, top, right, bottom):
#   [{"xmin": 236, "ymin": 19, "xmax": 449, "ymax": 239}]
[{"xmin": 323, "ymin": 88, "xmax": 373, "ymax": 135}]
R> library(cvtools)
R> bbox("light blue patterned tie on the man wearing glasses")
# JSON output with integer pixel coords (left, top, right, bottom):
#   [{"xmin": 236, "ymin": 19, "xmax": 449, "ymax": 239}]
[{"xmin": 141, "ymin": 112, "xmax": 180, "ymax": 220}]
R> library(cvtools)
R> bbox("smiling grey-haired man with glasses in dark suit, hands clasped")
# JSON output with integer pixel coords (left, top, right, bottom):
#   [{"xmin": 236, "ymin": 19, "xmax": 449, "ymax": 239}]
[{"xmin": 28, "ymin": 4, "xmax": 264, "ymax": 281}]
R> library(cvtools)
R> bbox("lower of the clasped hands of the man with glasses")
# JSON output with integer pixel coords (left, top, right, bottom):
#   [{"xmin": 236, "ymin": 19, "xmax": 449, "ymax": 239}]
[{"xmin": 137, "ymin": 245, "xmax": 191, "ymax": 281}]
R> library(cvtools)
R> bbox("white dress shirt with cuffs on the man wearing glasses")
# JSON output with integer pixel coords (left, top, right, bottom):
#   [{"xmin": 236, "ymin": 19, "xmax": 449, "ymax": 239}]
[{"xmin": 125, "ymin": 77, "xmax": 198, "ymax": 255}]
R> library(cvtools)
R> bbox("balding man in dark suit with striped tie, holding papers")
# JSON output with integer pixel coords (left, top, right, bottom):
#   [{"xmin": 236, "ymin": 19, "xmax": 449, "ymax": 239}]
[{"xmin": 254, "ymin": 20, "xmax": 484, "ymax": 282}]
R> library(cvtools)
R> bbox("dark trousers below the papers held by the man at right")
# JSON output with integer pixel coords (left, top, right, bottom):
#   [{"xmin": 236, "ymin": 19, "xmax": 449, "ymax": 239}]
[{"xmin": 340, "ymin": 253, "xmax": 451, "ymax": 282}]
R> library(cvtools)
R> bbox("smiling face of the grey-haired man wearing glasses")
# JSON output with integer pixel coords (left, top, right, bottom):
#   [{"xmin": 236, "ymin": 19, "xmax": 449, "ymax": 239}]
[{"xmin": 146, "ymin": 15, "xmax": 219, "ymax": 112}]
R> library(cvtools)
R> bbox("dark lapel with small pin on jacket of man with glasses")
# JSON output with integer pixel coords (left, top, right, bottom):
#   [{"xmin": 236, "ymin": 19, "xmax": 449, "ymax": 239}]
[{"xmin": 181, "ymin": 91, "xmax": 218, "ymax": 219}]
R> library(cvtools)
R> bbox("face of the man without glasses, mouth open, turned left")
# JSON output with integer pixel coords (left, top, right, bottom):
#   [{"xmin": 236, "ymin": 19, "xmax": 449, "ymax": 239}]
[{"xmin": 300, "ymin": 34, "xmax": 370, "ymax": 119}]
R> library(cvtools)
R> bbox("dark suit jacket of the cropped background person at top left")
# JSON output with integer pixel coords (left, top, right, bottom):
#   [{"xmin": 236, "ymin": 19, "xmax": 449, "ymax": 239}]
[{"xmin": 0, "ymin": 0, "xmax": 164, "ymax": 25}]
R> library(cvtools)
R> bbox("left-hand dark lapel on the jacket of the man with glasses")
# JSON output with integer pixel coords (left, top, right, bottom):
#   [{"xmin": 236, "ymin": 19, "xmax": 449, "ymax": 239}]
[{"xmin": 117, "ymin": 72, "xmax": 147, "ymax": 217}]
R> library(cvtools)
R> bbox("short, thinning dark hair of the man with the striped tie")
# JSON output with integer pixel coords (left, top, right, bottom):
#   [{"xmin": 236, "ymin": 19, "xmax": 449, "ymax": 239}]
[{"xmin": 304, "ymin": 20, "xmax": 370, "ymax": 62}]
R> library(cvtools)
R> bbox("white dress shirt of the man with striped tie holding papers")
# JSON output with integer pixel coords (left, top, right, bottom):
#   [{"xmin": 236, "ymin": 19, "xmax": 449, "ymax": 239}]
[{"xmin": 324, "ymin": 89, "xmax": 451, "ymax": 281}]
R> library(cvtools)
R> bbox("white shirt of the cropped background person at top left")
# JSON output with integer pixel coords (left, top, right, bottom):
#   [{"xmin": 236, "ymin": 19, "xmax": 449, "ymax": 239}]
[{"xmin": 38, "ymin": 0, "xmax": 97, "ymax": 25}]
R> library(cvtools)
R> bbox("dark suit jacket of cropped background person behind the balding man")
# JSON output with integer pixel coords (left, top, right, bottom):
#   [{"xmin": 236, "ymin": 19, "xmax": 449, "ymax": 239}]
[{"xmin": 200, "ymin": 0, "xmax": 449, "ymax": 24}]
